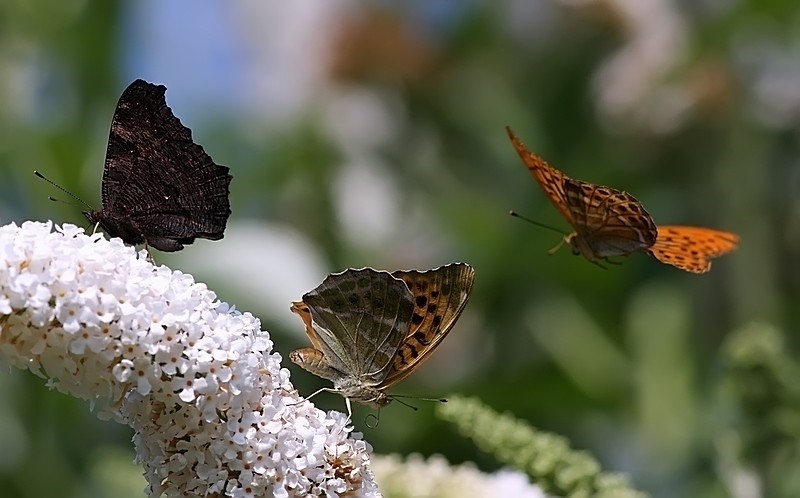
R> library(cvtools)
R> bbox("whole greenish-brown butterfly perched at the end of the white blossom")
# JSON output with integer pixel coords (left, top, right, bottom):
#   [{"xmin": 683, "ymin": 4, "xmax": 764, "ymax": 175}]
[{"xmin": 289, "ymin": 263, "xmax": 474, "ymax": 407}]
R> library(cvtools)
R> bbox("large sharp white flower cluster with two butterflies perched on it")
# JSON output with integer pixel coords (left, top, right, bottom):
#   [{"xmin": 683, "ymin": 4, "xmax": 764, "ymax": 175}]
[{"xmin": 0, "ymin": 222, "xmax": 380, "ymax": 497}]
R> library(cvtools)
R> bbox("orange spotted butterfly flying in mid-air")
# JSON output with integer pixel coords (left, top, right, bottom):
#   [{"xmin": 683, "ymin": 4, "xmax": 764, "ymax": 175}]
[{"xmin": 506, "ymin": 127, "xmax": 739, "ymax": 273}]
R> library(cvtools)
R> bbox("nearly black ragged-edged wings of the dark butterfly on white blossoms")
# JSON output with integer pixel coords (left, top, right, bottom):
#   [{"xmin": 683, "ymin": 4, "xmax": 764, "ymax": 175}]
[{"xmin": 102, "ymin": 80, "xmax": 232, "ymax": 250}]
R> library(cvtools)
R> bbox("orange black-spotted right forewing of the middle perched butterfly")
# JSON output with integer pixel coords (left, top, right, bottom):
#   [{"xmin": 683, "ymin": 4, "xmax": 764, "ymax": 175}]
[{"xmin": 382, "ymin": 263, "xmax": 475, "ymax": 387}]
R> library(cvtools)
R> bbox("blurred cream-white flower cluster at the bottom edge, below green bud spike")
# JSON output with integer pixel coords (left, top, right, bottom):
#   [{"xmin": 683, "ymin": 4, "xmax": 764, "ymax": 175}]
[{"xmin": 372, "ymin": 455, "xmax": 545, "ymax": 498}]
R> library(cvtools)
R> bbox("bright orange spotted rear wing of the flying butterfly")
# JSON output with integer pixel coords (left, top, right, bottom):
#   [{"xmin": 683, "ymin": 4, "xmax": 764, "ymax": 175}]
[{"xmin": 647, "ymin": 226, "xmax": 739, "ymax": 273}]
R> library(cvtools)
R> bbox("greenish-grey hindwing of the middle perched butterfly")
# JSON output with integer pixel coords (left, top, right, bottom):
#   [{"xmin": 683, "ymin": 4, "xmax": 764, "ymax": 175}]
[{"xmin": 301, "ymin": 268, "xmax": 414, "ymax": 386}]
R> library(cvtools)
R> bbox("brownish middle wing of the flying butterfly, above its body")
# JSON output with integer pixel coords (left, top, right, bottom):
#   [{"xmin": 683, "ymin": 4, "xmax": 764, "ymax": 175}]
[{"xmin": 564, "ymin": 178, "xmax": 658, "ymax": 254}]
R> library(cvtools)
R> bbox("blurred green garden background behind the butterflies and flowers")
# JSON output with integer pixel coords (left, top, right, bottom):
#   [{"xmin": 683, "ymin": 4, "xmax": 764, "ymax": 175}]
[{"xmin": 0, "ymin": 0, "xmax": 800, "ymax": 497}]
